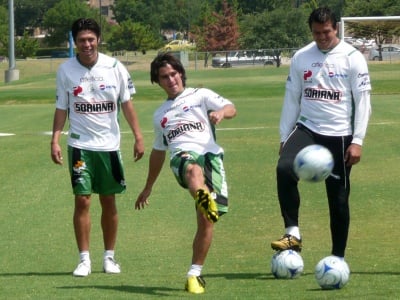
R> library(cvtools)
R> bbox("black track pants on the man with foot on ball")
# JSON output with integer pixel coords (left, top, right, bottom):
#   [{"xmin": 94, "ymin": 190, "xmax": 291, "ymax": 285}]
[{"xmin": 276, "ymin": 125, "xmax": 352, "ymax": 257}]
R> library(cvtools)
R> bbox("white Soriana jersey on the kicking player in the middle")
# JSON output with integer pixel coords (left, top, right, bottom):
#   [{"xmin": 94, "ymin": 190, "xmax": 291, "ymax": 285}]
[{"xmin": 153, "ymin": 88, "xmax": 232, "ymax": 157}]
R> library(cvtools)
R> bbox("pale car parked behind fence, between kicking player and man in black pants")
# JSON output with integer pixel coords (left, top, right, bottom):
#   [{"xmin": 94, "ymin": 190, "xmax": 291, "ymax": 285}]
[{"xmin": 211, "ymin": 51, "xmax": 276, "ymax": 68}]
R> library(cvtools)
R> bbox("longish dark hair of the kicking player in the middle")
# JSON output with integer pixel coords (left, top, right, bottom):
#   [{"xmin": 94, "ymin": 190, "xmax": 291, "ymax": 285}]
[{"xmin": 150, "ymin": 52, "xmax": 186, "ymax": 87}]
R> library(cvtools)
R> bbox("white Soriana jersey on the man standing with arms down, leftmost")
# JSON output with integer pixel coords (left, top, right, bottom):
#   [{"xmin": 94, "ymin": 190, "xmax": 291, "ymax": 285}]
[{"xmin": 56, "ymin": 53, "xmax": 135, "ymax": 151}]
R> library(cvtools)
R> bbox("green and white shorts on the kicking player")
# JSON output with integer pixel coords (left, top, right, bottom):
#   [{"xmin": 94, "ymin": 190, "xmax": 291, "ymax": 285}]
[{"xmin": 170, "ymin": 151, "xmax": 228, "ymax": 214}]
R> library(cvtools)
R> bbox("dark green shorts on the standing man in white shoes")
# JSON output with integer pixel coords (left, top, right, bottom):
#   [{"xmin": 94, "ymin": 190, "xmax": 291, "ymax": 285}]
[{"xmin": 68, "ymin": 146, "xmax": 126, "ymax": 195}]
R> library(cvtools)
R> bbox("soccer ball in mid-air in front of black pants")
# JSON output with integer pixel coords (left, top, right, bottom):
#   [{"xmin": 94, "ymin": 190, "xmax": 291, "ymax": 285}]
[{"xmin": 293, "ymin": 144, "xmax": 333, "ymax": 182}]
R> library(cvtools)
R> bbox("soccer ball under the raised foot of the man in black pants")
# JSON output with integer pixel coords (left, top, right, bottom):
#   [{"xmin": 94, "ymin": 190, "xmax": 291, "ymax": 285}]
[{"xmin": 271, "ymin": 250, "xmax": 304, "ymax": 279}]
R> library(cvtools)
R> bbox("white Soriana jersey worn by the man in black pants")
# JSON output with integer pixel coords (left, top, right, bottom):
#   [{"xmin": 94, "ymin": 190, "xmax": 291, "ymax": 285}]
[{"xmin": 281, "ymin": 41, "xmax": 371, "ymax": 139}]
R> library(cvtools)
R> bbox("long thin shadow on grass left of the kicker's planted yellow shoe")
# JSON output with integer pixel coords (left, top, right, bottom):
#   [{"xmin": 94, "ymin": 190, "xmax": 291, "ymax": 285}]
[{"xmin": 57, "ymin": 285, "xmax": 183, "ymax": 297}]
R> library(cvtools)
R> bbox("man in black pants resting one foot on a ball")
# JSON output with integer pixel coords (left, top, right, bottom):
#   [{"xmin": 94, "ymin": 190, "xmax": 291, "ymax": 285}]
[{"xmin": 271, "ymin": 7, "xmax": 371, "ymax": 264}]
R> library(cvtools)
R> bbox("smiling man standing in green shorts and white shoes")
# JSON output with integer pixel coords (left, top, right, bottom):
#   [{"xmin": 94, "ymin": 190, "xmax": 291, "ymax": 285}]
[{"xmin": 51, "ymin": 19, "xmax": 144, "ymax": 276}]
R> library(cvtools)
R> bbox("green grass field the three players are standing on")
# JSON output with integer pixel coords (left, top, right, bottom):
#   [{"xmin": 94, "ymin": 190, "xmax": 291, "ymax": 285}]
[{"xmin": 0, "ymin": 59, "xmax": 400, "ymax": 299}]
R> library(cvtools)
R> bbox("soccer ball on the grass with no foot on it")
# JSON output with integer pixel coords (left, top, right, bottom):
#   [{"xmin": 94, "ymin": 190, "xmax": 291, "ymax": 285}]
[{"xmin": 315, "ymin": 255, "xmax": 350, "ymax": 290}]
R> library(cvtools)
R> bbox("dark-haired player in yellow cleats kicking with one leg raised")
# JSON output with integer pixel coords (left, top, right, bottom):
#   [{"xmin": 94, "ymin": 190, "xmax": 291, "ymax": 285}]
[{"xmin": 135, "ymin": 53, "xmax": 236, "ymax": 294}]
